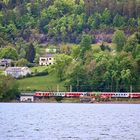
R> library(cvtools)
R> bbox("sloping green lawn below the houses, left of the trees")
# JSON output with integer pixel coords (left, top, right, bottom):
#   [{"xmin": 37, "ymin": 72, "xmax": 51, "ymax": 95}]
[{"xmin": 17, "ymin": 74, "xmax": 65, "ymax": 91}]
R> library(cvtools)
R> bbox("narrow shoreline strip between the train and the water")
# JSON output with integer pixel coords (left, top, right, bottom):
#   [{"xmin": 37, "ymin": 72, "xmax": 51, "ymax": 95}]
[{"xmin": 0, "ymin": 97, "xmax": 140, "ymax": 104}]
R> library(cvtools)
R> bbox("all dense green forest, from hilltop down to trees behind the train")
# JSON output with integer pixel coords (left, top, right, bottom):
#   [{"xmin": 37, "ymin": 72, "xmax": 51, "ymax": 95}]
[{"xmin": 0, "ymin": 0, "xmax": 140, "ymax": 92}]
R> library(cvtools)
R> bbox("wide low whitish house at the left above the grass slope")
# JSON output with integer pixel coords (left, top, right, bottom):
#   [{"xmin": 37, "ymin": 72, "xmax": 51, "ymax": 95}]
[{"xmin": 5, "ymin": 67, "xmax": 31, "ymax": 78}]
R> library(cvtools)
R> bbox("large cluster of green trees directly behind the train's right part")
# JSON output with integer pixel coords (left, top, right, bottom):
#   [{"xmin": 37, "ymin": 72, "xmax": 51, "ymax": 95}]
[{"xmin": 59, "ymin": 31, "xmax": 140, "ymax": 92}]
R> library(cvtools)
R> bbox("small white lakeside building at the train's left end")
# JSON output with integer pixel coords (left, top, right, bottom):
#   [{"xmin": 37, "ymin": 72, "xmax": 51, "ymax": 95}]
[{"xmin": 20, "ymin": 93, "xmax": 34, "ymax": 102}]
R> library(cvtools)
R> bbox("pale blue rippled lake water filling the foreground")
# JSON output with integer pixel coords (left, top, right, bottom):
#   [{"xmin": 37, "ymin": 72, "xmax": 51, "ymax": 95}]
[{"xmin": 0, "ymin": 103, "xmax": 140, "ymax": 140}]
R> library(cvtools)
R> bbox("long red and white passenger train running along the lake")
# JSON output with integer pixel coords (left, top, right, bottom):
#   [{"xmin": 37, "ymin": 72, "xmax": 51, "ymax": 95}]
[{"xmin": 33, "ymin": 91, "xmax": 140, "ymax": 98}]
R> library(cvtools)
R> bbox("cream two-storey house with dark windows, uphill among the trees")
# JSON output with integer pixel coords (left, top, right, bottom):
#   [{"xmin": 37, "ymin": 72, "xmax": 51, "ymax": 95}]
[{"xmin": 39, "ymin": 54, "xmax": 54, "ymax": 66}]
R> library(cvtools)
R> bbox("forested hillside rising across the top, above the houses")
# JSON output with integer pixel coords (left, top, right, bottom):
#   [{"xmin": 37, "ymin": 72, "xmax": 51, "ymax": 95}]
[{"xmin": 0, "ymin": 0, "xmax": 140, "ymax": 46}]
